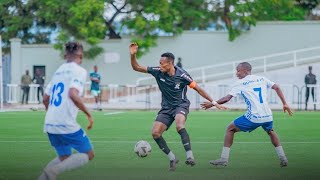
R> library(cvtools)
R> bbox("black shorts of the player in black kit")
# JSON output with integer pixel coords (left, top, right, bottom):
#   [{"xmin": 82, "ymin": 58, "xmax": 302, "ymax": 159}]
[{"xmin": 156, "ymin": 107, "xmax": 189, "ymax": 129}]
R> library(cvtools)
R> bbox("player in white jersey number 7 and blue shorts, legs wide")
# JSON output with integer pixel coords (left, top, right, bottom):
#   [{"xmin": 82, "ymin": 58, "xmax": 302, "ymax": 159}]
[{"xmin": 201, "ymin": 62, "xmax": 292, "ymax": 167}]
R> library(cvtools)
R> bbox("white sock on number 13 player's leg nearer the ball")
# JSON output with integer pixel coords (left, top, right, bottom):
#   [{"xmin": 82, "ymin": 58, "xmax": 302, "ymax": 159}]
[{"xmin": 50, "ymin": 153, "xmax": 89, "ymax": 175}]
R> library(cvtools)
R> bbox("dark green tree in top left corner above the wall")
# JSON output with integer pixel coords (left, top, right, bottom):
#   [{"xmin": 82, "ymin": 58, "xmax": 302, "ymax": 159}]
[{"xmin": 0, "ymin": 0, "xmax": 55, "ymax": 53}]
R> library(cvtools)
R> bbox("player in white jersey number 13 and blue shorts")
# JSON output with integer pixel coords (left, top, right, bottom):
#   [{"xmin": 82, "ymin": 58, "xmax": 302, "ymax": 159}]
[{"xmin": 38, "ymin": 42, "xmax": 94, "ymax": 180}]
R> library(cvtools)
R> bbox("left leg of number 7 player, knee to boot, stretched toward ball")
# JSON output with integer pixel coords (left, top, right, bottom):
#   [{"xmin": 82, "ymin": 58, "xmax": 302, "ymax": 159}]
[{"xmin": 209, "ymin": 122, "xmax": 240, "ymax": 166}]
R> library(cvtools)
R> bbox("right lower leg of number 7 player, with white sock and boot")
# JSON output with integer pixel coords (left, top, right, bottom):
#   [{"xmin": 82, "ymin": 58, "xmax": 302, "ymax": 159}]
[{"xmin": 268, "ymin": 130, "xmax": 288, "ymax": 167}]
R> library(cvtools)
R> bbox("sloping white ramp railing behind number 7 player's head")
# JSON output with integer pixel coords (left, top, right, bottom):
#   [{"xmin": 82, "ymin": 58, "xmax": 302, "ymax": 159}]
[{"xmin": 136, "ymin": 46, "xmax": 320, "ymax": 85}]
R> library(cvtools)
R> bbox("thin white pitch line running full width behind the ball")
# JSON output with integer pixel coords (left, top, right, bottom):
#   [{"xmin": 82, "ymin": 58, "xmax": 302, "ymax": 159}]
[{"xmin": 0, "ymin": 140, "xmax": 320, "ymax": 144}]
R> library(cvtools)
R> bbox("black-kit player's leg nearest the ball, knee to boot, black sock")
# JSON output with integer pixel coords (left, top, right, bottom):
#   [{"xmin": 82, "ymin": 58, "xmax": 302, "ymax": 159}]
[{"xmin": 152, "ymin": 121, "xmax": 179, "ymax": 171}]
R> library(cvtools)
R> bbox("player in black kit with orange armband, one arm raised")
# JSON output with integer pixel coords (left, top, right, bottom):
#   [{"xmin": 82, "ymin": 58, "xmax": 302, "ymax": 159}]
[{"xmin": 129, "ymin": 43, "xmax": 226, "ymax": 171}]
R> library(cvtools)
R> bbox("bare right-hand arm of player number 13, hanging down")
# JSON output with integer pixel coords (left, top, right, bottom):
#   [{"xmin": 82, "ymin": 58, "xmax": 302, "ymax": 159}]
[{"xmin": 69, "ymin": 88, "xmax": 93, "ymax": 130}]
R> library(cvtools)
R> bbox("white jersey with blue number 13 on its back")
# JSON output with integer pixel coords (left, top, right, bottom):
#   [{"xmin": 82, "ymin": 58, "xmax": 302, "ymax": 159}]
[{"xmin": 44, "ymin": 62, "xmax": 87, "ymax": 134}]
